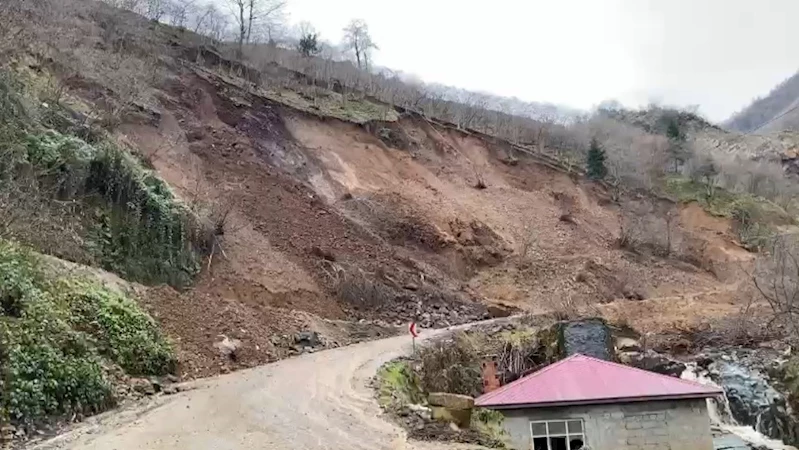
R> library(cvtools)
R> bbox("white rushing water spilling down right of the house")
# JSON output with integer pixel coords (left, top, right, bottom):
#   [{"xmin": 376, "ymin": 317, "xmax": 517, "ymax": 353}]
[{"xmin": 681, "ymin": 364, "xmax": 797, "ymax": 450}]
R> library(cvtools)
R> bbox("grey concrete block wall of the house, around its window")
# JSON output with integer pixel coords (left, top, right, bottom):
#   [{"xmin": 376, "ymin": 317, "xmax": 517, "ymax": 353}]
[{"xmin": 502, "ymin": 399, "xmax": 713, "ymax": 450}]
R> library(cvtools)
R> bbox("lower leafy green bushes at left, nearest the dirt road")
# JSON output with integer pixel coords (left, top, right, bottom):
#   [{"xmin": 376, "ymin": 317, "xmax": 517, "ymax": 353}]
[{"xmin": 0, "ymin": 241, "xmax": 175, "ymax": 425}]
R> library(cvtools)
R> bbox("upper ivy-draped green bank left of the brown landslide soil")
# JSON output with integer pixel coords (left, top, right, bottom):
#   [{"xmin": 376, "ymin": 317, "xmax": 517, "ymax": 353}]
[{"xmin": 0, "ymin": 73, "xmax": 210, "ymax": 287}]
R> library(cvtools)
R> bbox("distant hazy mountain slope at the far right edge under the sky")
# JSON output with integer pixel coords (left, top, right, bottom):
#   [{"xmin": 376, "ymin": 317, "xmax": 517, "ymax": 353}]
[{"xmin": 724, "ymin": 72, "xmax": 799, "ymax": 133}]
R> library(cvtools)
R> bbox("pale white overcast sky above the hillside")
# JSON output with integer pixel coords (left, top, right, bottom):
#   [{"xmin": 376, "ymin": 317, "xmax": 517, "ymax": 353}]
[{"xmin": 288, "ymin": 0, "xmax": 799, "ymax": 121}]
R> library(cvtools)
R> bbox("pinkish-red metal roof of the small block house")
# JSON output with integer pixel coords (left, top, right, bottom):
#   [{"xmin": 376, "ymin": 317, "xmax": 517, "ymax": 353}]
[{"xmin": 475, "ymin": 355, "xmax": 722, "ymax": 409}]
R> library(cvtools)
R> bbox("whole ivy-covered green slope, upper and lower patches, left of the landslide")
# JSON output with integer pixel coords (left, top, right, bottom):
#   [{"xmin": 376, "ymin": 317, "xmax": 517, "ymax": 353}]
[{"xmin": 0, "ymin": 69, "xmax": 200, "ymax": 428}]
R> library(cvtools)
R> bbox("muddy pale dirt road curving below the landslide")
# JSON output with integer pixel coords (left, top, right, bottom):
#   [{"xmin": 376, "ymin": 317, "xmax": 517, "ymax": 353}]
[{"xmin": 38, "ymin": 330, "xmax": 476, "ymax": 450}]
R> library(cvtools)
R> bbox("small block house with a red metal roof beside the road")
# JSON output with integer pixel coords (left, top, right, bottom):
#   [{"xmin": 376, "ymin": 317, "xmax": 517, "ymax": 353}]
[{"xmin": 475, "ymin": 354, "xmax": 723, "ymax": 450}]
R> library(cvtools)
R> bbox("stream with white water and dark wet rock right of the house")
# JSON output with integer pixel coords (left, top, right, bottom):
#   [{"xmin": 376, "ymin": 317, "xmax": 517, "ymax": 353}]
[{"xmin": 681, "ymin": 361, "xmax": 797, "ymax": 450}]
